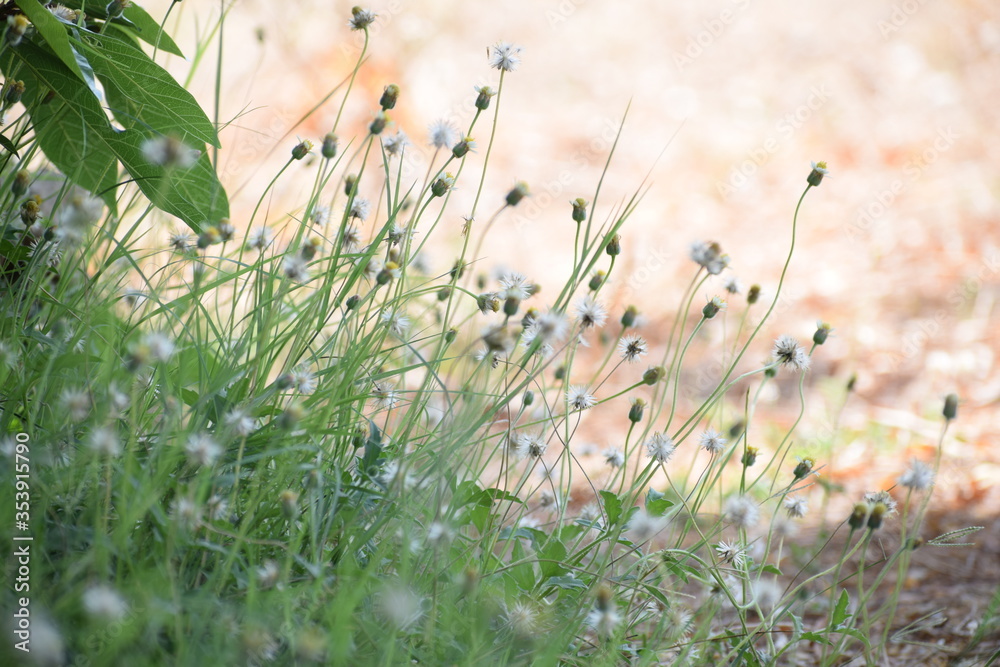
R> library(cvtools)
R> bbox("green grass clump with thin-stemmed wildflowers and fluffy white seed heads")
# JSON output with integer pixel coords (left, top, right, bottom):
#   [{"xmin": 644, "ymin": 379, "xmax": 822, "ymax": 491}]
[{"xmin": 0, "ymin": 2, "xmax": 972, "ymax": 666}]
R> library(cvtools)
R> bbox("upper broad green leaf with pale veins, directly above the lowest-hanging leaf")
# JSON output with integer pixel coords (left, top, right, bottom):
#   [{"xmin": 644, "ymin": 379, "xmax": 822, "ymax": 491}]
[{"xmin": 73, "ymin": 34, "xmax": 219, "ymax": 148}]
